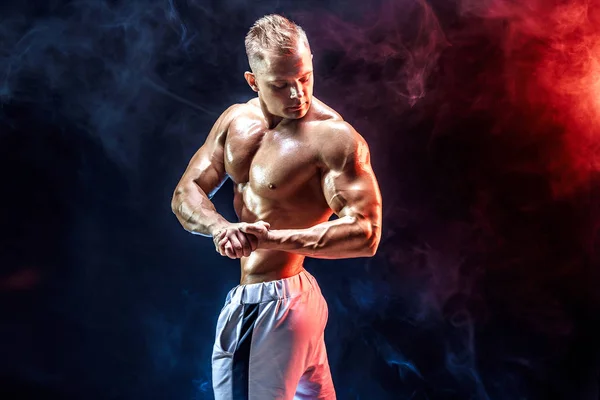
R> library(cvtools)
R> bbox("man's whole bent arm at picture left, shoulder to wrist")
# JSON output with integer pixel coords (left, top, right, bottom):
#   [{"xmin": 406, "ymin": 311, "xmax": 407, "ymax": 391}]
[{"xmin": 171, "ymin": 104, "xmax": 238, "ymax": 236}]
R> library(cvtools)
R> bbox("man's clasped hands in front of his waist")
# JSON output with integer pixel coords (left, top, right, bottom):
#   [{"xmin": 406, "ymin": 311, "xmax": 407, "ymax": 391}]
[{"xmin": 213, "ymin": 221, "xmax": 270, "ymax": 259}]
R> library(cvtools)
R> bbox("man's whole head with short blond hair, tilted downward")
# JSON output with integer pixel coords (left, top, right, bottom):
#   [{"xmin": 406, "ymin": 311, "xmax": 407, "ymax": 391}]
[{"xmin": 244, "ymin": 15, "xmax": 313, "ymax": 119}]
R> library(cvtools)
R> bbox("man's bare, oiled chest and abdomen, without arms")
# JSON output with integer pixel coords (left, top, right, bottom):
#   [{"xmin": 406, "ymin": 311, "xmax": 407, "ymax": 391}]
[{"xmin": 225, "ymin": 98, "xmax": 341, "ymax": 284}]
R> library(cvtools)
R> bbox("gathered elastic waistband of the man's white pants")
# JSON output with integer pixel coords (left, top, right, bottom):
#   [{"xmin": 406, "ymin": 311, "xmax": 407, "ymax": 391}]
[{"xmin": 226, "ymin": 269, "xmax": 318, "ymax": 304}]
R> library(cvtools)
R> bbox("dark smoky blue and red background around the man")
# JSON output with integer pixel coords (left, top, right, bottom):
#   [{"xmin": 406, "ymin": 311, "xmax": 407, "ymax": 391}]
[{"xmin": 0, "ymin": 0, "xmax": 600, "ymax": 400}]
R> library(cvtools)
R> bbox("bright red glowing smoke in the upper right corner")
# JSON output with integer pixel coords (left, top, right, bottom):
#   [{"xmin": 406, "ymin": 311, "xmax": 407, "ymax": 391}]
[{"xmin": 461, "ymin": 0, "xmax": 600, "ymax": 195}]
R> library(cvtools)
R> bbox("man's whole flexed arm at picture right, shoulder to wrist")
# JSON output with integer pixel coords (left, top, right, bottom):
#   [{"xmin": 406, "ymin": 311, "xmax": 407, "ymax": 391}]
[{"xmin": 248, "ymin": 122, "xmax": 381, "ymax": 259}]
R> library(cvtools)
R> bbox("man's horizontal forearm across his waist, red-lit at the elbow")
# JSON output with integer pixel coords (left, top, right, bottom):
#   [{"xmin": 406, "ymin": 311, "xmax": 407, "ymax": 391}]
[{"xmin": 260, "ymin": 216, "xmax": 379, "ymax": 259}]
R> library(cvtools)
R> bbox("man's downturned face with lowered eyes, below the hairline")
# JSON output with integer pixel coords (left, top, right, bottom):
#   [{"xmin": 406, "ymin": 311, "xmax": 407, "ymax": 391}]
[{"xmin": 250, "ymin": 41, "xmax": 313, "ymax": 119}]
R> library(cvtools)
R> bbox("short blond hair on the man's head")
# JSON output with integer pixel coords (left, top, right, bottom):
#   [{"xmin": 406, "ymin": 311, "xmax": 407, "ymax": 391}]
[{"xmin": 245, "ymin": 14, "xmax": 310, "ymax": 72}]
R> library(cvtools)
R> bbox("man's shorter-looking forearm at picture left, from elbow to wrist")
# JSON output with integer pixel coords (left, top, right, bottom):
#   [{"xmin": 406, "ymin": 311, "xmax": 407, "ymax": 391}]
[{"xmin": 171, "ymin": 182, "xmax": 228, "ymax": 236}]
